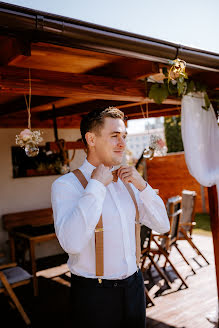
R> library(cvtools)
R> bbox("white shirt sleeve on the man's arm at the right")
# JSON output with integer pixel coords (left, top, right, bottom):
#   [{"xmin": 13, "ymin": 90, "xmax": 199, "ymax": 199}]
[{"xmin": 133, "ymin": 183, "xmax": 170, "ymax": 233}]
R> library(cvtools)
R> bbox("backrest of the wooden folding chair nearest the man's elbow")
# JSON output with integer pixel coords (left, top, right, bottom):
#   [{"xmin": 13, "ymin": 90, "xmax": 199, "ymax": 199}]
[{"xmin": 166, "ymin": 195, "xmax": 182, "ymax": 247}]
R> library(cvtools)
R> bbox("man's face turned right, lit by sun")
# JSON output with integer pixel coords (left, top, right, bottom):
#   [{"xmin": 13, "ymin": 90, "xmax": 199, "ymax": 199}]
[{"xmin": 87, "ymin": 117, "xmax": 127, "ymax": 167}]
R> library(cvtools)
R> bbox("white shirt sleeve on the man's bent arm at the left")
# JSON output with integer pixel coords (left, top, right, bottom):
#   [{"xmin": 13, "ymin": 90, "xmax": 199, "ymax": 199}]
[{"xmin": 51, "ymin": 179, "xmax": 106, "ymax": 254}]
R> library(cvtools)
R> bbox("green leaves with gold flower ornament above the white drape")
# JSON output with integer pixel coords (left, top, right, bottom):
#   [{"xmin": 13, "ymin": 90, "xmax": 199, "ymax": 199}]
[{"xmin": 145, "ymin": 58, "xmax": 210, "ymax": 110}]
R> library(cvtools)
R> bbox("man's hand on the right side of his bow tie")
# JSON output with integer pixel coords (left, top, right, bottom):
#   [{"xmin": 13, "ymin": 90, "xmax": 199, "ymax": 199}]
[{"xmin": 118, "ymin": 165, "xmax": 147, "ymax": 191}]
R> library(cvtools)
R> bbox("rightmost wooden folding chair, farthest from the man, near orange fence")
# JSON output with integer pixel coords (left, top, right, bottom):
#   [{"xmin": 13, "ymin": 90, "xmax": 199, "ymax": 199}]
[{"xmin": 176, "ymin": 190, "xmax": 209, "ymax": 266}]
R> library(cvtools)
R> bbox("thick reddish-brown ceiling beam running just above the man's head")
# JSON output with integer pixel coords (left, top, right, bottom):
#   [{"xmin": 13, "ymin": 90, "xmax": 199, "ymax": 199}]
[{"xmin": 0, "ymin": 67, "xmax": 178, "ymax": 103}]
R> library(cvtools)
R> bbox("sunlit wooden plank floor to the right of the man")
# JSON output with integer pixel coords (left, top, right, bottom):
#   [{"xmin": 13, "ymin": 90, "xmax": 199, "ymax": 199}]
[{"xmin": 146, "ymin": 235, "xmax": 218, "ymax": 328}]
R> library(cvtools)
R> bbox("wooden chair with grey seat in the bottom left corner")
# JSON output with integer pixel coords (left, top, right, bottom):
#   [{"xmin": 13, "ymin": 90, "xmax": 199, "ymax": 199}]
[{"xmin": 0, "ymin": 262, "xmax": 32, "ymax": 326}]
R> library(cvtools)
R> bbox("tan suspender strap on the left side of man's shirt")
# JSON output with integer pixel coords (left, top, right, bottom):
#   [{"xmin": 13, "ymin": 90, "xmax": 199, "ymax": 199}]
[{"xmin": 73, "ymin": 169, "xmax": 104, "ymax": 277}]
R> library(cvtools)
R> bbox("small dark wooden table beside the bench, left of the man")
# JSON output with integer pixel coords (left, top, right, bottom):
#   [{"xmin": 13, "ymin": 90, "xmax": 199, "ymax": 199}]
[{"xmin": 9, "ymin": 224, "xmax": 56, "ymax": 296}]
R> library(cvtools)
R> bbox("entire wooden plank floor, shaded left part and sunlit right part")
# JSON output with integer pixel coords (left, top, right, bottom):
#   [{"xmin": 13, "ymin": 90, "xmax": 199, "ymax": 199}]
[{"xmin": 0, "ymin": 235, "xmax": 217, "ymax": 328}]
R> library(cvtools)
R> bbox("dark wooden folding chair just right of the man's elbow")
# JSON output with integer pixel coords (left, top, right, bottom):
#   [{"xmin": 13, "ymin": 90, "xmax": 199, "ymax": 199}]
[{"xmin": 142, "ymin": 196, "xmax": 188, "ymax": 288}]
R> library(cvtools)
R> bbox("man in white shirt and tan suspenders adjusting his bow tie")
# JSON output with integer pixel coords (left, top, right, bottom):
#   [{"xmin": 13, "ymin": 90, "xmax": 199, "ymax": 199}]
[{"xmin": 52, "ymin": 107, "xmax": 169, "ymax": 328}]
